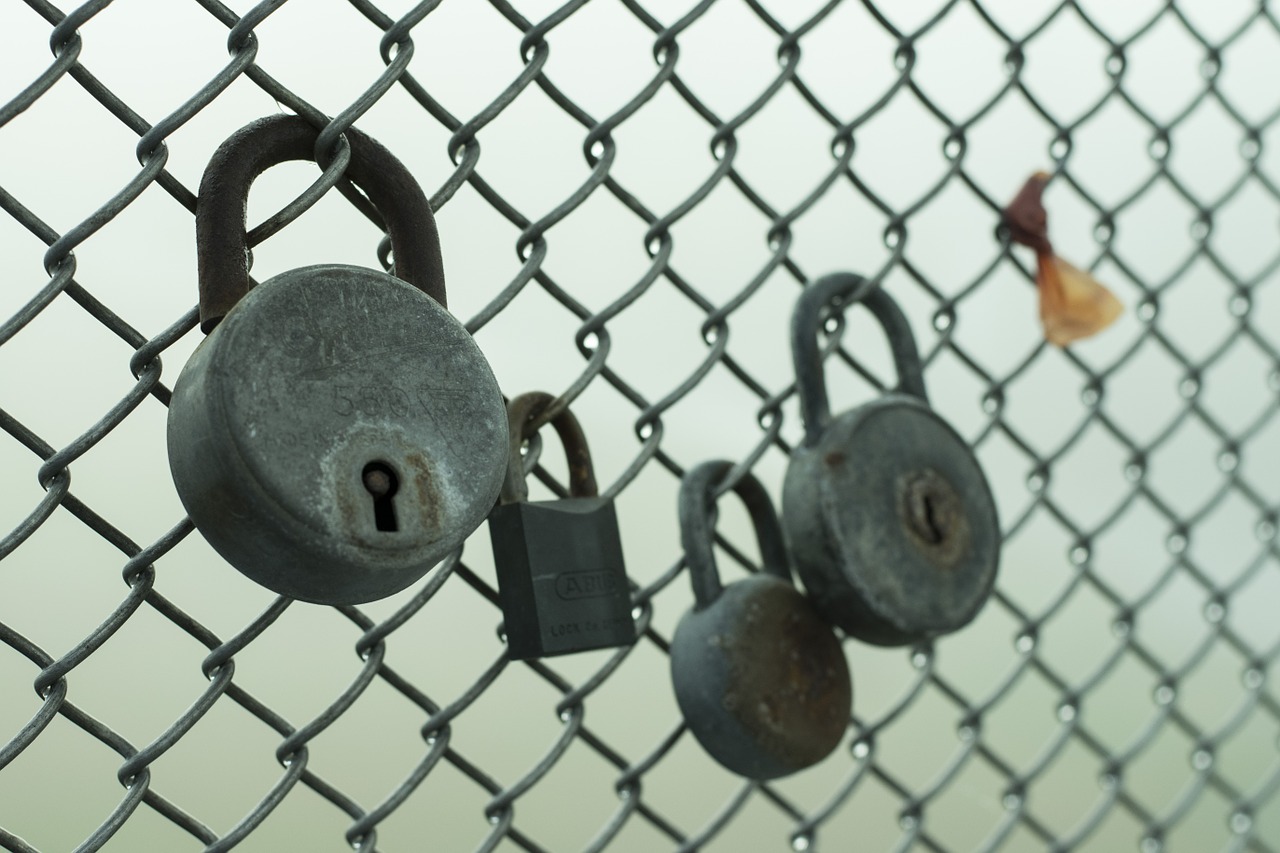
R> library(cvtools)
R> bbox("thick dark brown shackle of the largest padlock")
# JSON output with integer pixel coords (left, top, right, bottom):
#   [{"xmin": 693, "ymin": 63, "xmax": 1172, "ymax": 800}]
[{"xmin": 196, "ymin": 115, "xmax": 447, "ymax": 334}]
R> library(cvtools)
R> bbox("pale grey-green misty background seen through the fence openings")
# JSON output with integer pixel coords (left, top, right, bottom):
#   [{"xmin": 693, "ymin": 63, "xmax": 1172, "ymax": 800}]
[{"xmin": 0, "ymin": 0, "xmax": 1280, "ymax": 852}]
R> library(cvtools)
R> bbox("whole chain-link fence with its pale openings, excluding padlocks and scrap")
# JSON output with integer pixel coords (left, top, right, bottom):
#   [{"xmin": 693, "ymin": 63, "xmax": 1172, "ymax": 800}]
[{"xmin": 0, "ymin": 0, "xmax": 1280, "ymax": 853}]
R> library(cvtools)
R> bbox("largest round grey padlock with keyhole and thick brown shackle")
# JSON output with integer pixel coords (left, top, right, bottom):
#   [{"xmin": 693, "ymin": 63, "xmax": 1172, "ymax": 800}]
[{"xmin": 168, "ymin": 115, "xmax": 507, "ymax": 605}]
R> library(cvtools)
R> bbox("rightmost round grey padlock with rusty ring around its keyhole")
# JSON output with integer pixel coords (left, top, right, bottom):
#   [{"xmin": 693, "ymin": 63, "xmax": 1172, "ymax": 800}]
[{"xmin": 782, "ymin": 273, "xmax": 1000, "ymax": 646}]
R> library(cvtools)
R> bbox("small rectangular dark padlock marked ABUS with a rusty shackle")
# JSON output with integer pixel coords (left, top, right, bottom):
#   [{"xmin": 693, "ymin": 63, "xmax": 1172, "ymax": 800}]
[{"xmin": 489, "ymin": 392, "xmax": 636, "ymax": 661}]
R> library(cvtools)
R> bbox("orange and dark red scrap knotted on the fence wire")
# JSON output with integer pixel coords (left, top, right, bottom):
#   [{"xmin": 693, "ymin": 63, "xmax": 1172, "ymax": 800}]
[{"xmin": 1004, "ymin": 172, "xmax": 1124, "ymax": 347}]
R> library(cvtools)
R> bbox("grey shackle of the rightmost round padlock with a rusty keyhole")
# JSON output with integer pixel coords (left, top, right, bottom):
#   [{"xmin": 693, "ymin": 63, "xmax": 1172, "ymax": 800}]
[{"xmin": 791, "ymin": 273, "xmax": 929, "ymax": 446}]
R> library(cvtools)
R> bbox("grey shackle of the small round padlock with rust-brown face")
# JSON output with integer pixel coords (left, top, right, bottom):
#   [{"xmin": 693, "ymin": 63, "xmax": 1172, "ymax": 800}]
[{"xmin": 678, "ymin": 460, "xmax": 791, "ymax": 611}]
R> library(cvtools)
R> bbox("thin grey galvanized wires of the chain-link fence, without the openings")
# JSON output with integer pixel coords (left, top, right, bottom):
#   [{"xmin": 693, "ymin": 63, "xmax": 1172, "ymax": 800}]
[{"xmin": 0, "ymin": 0, "xmax": 1280, "ymax": 853}]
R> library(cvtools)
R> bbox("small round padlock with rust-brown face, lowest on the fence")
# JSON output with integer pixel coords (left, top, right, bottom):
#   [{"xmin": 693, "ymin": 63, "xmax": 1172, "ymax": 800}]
[{"xmin": 671, "ymin": 461, "xmax": 852, "ymax": 779}]
